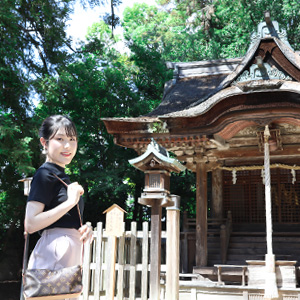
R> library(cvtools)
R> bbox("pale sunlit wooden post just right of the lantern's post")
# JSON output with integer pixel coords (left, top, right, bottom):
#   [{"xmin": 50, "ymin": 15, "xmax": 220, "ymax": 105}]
[{"xmin": 166, "ymin": 195, "xmax": 180, "ymax": 300}]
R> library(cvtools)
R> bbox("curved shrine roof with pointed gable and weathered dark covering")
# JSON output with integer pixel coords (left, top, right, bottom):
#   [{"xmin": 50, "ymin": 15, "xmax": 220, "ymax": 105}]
[{"xmin": 102, "ymin": 21, "xmax": 300, "ymax": 140}]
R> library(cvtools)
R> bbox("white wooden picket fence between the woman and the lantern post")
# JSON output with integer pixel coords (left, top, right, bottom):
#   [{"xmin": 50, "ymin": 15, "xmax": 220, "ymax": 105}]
[{"xmin": 81, "ymin": 222, "xmax": 166, "ymax": 300}]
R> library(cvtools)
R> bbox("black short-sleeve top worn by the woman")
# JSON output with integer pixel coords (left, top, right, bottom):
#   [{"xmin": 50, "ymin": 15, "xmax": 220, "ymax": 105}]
[{"xmin": 28, "ymin": 162, "xmax": 83, "ymax": 229}]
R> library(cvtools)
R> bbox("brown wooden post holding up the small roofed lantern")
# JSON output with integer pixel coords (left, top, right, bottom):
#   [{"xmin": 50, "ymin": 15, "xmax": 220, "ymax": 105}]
[{"xmin": 149, "ymin": 201, "xmax": 162, "ymax": 300}]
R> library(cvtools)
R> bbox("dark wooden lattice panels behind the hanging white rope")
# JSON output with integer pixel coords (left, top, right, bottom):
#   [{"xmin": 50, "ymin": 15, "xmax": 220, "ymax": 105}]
[{"xmin": 223, "ymin": 168, "xmax": 300, "ymax": 223}]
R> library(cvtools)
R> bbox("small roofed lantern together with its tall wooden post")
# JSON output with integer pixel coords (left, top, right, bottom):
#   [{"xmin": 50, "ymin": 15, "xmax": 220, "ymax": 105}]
[{"xmin": 129, "ymin": 139, "xmax": 185, "ymax": 300}]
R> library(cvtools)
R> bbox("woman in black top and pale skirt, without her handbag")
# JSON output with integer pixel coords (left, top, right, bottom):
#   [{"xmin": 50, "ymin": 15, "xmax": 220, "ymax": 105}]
[{"xmin": 25, "ymin": 115, "xmax": 92, "ymax": 299}]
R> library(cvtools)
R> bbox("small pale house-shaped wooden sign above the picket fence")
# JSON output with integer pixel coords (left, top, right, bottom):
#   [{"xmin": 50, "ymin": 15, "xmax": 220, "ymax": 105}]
[{"xmin": 103, "ymin": 204, "xmax": 126, "ymax": 236}]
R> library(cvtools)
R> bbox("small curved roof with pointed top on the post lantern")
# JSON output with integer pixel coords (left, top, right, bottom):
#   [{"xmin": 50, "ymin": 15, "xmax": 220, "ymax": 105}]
[{"xmin": 129, "ymin": 139, "xmax": 186, "ymax": 173}]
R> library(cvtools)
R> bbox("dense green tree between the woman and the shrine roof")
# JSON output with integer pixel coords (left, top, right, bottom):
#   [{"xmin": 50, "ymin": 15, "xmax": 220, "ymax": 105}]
[{"xmin": 34, "ymin": 22, "xmax": 155, "ymax": 224}]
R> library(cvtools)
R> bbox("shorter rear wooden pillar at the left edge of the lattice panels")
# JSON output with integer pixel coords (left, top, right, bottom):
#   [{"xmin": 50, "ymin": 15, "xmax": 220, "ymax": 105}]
[{"xmin": 212, "ymin": 169, "xmax": 223, "ymax": 220}]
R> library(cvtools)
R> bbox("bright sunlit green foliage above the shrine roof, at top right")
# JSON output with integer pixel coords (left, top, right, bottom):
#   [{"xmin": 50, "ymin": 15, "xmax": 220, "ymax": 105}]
[{"xmin": 123, "ymin": 0, "xmax": 300, "ymax": 62}]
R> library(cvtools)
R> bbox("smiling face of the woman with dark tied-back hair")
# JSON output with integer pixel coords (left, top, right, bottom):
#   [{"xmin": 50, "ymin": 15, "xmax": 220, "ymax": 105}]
[{"xmin": 41, "ymin": 127, "xmax": 77, "ymax": 168}]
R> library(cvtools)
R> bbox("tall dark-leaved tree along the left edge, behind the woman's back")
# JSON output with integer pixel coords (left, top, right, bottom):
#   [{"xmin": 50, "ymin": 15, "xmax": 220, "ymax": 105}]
[{"xmin": 0, "ymin": 0, "xmax": 120, "ymax": 282}]
